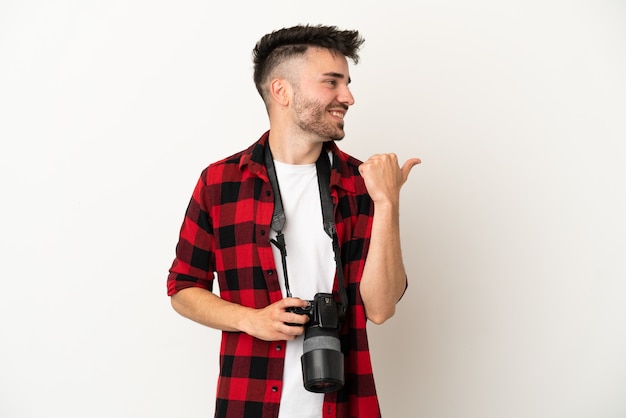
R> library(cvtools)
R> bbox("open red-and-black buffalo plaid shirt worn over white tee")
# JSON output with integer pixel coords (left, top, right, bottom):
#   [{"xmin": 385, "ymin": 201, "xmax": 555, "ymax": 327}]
[{"xmin": 167, "ymin": 132, "xmax": 380, "ymax": 418}]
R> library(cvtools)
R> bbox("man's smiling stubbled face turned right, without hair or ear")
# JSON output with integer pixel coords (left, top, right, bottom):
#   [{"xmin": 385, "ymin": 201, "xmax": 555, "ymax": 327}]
[{"xmin": 292, "ymin": 48, "xmax": 354, "ymax": 141}]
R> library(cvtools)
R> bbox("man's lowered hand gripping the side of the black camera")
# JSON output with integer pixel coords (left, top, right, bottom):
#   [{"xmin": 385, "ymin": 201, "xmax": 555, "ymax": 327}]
[{"xmin": 241, "ymin": 298, "xmax": 309, "ymax": 341}]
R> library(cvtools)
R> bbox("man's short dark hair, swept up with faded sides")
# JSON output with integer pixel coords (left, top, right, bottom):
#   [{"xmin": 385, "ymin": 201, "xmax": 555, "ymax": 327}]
[{"xmin": 252, "ymin": 25, "xmax": 364, "ymax": 104}]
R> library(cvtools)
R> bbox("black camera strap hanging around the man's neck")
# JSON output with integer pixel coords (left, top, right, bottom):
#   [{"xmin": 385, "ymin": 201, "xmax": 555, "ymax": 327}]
[{"xmin": 265, "ymin": 144, "xmax": 348, "ymax": 319}]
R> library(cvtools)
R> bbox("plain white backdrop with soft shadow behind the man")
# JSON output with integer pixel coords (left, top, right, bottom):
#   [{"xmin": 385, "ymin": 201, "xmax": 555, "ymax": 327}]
[{"xmin": 0, "ymin": 0, "xmax": 626, "ymax": 418}]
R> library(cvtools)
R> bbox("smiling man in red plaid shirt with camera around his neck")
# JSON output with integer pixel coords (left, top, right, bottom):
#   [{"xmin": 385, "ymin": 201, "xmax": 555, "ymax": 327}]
[{"xmin": 168, "ymin": 25, "xmax": 420, "ymax": 418}]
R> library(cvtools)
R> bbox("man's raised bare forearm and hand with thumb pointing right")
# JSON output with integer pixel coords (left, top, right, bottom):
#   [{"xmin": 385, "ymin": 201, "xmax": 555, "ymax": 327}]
[{"xmin": 359, "ymin": 154, "xmax": 421, "ymax": 324}]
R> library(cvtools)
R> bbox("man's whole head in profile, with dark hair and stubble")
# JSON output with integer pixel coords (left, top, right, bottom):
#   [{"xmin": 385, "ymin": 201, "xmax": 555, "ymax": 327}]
[{"xmin": 254, "ymin": 25, "xmax": 364, "ymax": 141}]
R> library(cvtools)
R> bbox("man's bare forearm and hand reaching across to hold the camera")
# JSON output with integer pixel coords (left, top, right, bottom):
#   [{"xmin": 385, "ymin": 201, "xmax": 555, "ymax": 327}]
[{"xmin": 171, "ymin": 287, "xmax": 308, "ymax": 341}]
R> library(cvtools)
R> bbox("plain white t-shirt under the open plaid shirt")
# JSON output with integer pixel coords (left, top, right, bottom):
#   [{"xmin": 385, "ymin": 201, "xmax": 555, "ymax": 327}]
[{"xmin": 271, "ymin": 161, "xmax": 335, "ymax": 418}]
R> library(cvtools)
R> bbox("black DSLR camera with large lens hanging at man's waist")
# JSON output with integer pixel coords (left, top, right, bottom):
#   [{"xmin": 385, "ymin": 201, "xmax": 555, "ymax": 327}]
[{"xmin": 290, "ymin": 293, "xmax": 345, "ymax": 393}]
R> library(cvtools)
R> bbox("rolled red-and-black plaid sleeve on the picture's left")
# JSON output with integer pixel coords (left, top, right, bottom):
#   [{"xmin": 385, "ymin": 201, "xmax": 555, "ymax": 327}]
[{"xmin": 167, "ymin": 170, "xmax": 215, "ymax": 296}]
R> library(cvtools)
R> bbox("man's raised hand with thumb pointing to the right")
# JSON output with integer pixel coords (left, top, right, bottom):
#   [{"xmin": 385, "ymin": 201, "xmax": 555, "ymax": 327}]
[{"xmin": 359, "ymin": 154, "xmax": 422, "ymax": 204}]
